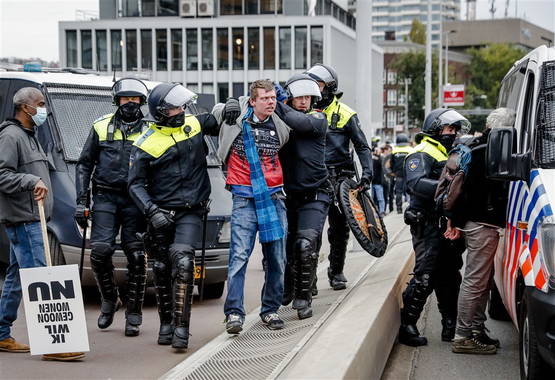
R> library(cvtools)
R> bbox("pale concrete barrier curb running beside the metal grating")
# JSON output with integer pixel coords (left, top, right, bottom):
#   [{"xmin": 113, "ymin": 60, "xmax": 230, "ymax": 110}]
[{"xmin": 278, "ymin": 226, "xmax": 414, "ymax": 379}]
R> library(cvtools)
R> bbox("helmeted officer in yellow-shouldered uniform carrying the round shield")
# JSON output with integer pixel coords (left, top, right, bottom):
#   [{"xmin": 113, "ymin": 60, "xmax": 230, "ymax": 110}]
[{"xmin": 306, "ymin": 63, "xmax": 372, "ymax": 290}]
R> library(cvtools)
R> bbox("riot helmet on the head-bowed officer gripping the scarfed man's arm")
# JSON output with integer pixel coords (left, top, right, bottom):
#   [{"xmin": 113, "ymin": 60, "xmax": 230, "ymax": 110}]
[{"xmin": 148, "ymin": 83, "xmax": 198, "ymax": 127}]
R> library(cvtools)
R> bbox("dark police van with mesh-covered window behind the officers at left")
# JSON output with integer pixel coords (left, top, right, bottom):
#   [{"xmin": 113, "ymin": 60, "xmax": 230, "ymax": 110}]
[{"xmin": 0, "ymin": 71, "xmax": 231, "ymax": 298}]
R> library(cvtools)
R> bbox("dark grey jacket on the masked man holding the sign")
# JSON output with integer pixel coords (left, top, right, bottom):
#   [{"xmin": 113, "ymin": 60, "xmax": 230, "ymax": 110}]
[{"xmin": 0, "ymin": 119, "xmax": 53, "ymax": 224}]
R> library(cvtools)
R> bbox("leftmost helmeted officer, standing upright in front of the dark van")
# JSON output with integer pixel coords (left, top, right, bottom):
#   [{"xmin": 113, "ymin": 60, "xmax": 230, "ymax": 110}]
[{"xmin": 75, "ymin": 78, "xmax": 148, "ymax": 336}]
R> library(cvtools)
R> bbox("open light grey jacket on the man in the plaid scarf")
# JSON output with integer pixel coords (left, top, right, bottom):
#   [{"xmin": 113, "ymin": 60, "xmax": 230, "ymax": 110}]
[{"xmin": 212, "ymin": 96, "xmax": 291, "ymax": 162}]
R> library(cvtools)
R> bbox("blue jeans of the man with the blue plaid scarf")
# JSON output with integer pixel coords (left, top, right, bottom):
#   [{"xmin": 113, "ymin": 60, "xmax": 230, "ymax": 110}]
[{"xmin": 224, "ymin": 195, "xmax": 287, "ymax": 317}]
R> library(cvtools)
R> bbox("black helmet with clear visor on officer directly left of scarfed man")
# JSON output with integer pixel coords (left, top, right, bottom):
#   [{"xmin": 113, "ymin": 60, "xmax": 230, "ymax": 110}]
[{"xmin": 148, "ymin": 83, "xmax": 197, "ymax": 125}]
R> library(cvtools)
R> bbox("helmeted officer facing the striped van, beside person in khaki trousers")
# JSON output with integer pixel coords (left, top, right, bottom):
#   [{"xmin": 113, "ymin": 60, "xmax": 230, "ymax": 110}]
[{"xmin": 399, "ymin": 108, "xmax": 470, "ymax": 346}]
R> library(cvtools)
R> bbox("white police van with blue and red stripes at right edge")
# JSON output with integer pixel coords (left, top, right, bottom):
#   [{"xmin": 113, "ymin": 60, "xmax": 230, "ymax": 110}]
[{"xmin": 486, "ymin": 46, "xmax": 555, "ymax": 380}]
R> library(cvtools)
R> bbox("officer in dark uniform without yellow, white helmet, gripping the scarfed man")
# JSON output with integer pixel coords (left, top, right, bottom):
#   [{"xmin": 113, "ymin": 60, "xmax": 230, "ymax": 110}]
[{"xmin": 280, "ymin": 74, "xmax": 333, "ymax": 319}]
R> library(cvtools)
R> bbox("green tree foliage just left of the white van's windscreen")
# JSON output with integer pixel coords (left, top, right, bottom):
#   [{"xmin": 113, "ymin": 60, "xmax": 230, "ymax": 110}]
[{"xmin": 466, "ymin": 44, "xmax": 525, "ymax": 108}]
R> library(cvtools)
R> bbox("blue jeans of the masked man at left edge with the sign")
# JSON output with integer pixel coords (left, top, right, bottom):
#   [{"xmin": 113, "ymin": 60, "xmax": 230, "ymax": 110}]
[{"xmin": 0, "ymin": 222, "xmax": 46, "ymax": 340}]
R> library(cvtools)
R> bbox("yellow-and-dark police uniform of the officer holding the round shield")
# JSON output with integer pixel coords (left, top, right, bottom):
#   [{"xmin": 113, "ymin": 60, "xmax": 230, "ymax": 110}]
[{"xmin": 323, "ymin": 96, "xmax": 372, "ymax": 289}]
